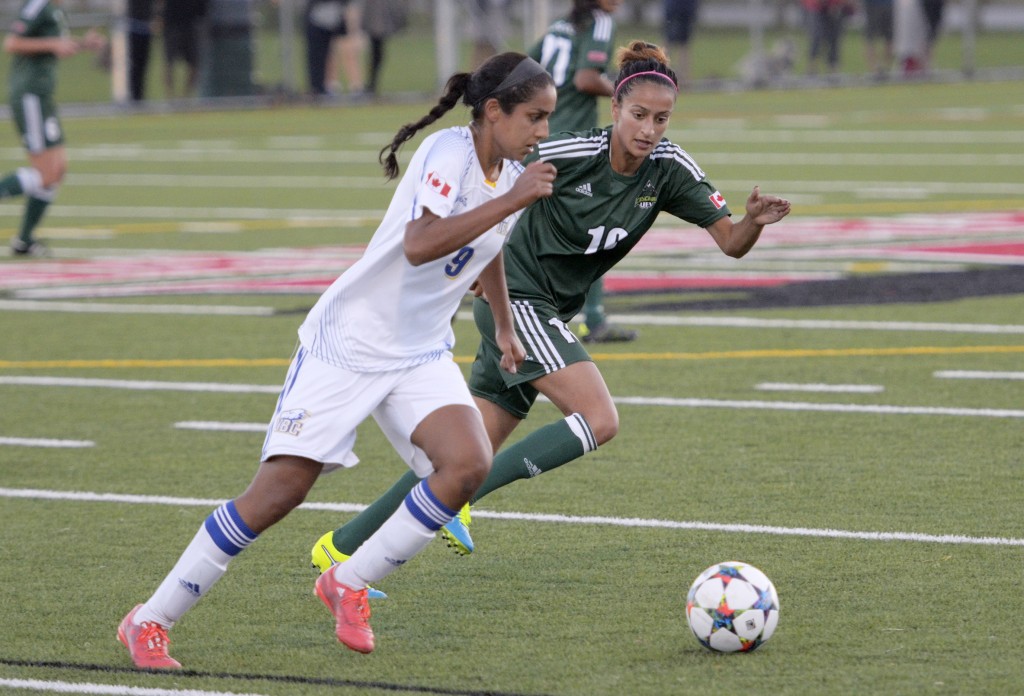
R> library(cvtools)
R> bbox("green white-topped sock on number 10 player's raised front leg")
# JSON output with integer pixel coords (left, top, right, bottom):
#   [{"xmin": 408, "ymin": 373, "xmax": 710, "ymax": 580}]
[{"xmin": 471, "ymin": 414, "xmax": 597, "ymax": 503}]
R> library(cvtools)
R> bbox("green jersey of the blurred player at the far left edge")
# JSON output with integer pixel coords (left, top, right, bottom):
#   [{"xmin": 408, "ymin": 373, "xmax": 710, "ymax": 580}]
[{"xmin": 7, "ymin": 0, "xmax": 71, "ymax": 95}]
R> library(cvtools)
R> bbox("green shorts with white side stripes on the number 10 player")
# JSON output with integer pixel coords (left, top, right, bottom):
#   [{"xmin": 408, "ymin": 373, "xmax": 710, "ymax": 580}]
[{"xmin": 469, "ymin": 298, "xmax": 592, "ymax": 419}]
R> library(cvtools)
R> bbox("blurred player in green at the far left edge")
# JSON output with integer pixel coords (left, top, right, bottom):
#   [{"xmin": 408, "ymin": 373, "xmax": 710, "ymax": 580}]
[{"xmin": 0, "ymin": 0, "xmax": 106, "ymax": 256}]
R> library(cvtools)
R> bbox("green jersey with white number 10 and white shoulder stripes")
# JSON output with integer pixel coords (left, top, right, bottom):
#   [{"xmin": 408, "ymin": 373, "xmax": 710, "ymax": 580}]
[{"xmin": 505, "ymin": 127, "xmax": 730, "ymax": 321}]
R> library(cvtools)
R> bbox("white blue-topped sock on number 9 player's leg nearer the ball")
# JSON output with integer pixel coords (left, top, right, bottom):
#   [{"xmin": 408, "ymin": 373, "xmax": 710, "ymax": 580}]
[{"xmin": 333, "ymin": 479, "xmax": 457, "ymax": 589}]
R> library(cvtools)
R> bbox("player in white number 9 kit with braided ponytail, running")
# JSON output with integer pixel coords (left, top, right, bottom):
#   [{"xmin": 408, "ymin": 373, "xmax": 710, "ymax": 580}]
[{"xmin": 118, "ymin": 52, "xmax": 556, "ymax": 669}]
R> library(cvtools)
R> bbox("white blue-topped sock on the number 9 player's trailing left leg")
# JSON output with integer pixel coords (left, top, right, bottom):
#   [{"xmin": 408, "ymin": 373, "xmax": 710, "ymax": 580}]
[{"xmin": 134, "ymin": 501, "xmax": 257, "ymax": 628}]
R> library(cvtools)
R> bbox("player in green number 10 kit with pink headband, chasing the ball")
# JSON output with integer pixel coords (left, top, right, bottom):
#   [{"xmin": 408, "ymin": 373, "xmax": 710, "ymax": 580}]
[{"xmin": 312, "ymin": 41, "xmax": 790, "ymax": 571}]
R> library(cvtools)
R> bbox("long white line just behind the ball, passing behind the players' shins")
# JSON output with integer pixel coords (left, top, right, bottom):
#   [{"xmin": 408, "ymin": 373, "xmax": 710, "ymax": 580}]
[{"xmin": 0, "ymin": 488, "xmax": 1024, "ymax": 547}]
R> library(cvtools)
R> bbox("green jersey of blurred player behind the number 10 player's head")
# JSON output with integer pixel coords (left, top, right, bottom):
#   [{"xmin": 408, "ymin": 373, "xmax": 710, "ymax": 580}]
[{"xmin": 529, "ymin": 9, "xmax": 615, "ymax": 133}]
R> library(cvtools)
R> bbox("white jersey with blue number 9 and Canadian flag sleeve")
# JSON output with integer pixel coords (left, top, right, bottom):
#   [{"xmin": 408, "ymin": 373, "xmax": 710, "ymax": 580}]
[{"xmin": 299, "ymin": 126, "xmax": 522, "ymax": 373}]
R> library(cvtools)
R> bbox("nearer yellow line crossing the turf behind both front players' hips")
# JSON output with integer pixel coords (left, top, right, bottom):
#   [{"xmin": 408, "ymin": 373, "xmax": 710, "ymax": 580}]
[{"xmin": 0, "ymin": 346, "xmax": 1024, "ymax": 369}]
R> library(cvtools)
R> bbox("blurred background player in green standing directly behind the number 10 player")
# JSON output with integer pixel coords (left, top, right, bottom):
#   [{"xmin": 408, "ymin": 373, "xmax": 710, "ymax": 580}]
[{"xmin": 529, "ymin": 0, "xmax": 637, "ymax": 343}]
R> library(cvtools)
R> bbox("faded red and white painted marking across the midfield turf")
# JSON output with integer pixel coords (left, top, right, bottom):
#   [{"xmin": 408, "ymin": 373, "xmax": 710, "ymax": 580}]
[{"xmin": 8, "ymin": 212, "xmax": 1024, "ymax": 298}]
